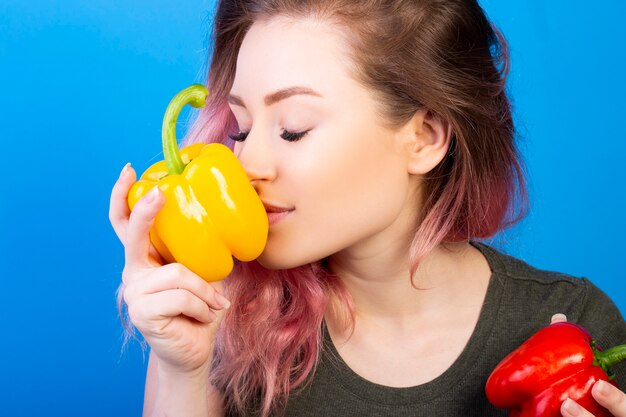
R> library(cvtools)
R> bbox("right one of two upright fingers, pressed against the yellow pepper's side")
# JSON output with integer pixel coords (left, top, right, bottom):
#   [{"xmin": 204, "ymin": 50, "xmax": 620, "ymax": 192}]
[{"xmin": 124, "ymin": 187, "xmax": 165, "ymax": 269}]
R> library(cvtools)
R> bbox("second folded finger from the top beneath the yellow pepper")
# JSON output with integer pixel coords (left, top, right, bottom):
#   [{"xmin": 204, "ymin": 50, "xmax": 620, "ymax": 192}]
[{"xmin": 128, "ymin": 289, "xmax": 217, "ymax": 331}]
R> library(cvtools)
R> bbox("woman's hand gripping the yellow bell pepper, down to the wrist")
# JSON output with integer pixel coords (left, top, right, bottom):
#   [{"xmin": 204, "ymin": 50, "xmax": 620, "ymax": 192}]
[{"xmin": 109, "ymin": 165, "xmax": 230, "ymax": 373}]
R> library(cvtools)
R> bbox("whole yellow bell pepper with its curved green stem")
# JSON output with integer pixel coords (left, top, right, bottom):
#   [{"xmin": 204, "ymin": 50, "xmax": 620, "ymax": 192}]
[{"xmin": 128, "ymin": 84, "xmax": 268, "ymax": 281}]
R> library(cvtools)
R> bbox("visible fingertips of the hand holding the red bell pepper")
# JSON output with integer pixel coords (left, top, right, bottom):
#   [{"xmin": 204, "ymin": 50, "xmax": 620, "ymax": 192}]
[{"xmin": 552, "ymin": 314, "xmax": 626, "ymax": 417}]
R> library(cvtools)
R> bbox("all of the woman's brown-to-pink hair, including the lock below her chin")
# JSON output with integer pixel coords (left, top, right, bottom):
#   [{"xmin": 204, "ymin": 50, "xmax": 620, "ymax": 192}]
[{"xmin": 149, "ymin": 0, "xmax": 526, "ymax": 416}]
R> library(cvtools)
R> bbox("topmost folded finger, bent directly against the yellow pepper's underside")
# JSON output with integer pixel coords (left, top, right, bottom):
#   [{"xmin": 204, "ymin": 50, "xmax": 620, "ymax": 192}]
[{"xmin": 124, "ymin": 263, "xmax": 230, "ymax": 310}]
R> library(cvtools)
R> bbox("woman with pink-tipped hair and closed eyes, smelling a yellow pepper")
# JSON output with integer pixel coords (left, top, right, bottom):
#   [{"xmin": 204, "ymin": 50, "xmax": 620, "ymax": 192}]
[{"xmin": 110, "ymin": 0, "xmax": 626, "ymax": 416}]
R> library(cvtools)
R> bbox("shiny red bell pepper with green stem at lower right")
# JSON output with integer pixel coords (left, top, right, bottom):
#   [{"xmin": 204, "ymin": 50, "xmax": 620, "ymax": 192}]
[{"xmin": 485, "ymin": 322, "xmax": 626, "ymax": 417}]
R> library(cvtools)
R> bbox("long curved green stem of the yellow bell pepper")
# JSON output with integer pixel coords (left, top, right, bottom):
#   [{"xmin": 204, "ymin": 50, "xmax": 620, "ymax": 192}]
[{"xmin": 161, "ymin": 84, "xmax": 209, "ymax": 175}]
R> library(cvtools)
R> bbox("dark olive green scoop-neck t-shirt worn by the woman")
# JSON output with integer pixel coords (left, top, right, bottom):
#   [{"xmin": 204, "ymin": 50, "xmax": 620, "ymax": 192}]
[{"xmin": 230, "ymin": 243, "xmax": 626, "ymax": 417}]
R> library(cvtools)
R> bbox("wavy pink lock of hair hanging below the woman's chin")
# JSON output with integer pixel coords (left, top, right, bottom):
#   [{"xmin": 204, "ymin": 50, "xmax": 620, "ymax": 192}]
[{"xmin": 211, "ymin": 262, "xmax": 352, "ymax": 415}]
